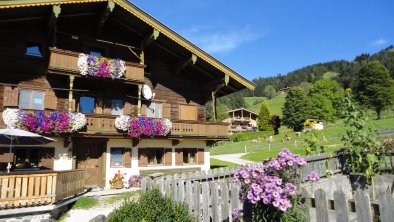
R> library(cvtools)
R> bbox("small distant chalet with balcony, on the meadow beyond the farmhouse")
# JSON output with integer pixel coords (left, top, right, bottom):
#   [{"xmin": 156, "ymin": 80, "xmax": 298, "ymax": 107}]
[{"xmin": 223, "ymin": 108, "xmax": 258, "ymax": 134}]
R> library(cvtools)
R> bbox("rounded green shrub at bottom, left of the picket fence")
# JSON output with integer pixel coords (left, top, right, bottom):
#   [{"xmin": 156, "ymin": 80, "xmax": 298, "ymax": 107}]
[{"xmin": 108, "ymin": 188, "xmax": 194, "ymax": 222}]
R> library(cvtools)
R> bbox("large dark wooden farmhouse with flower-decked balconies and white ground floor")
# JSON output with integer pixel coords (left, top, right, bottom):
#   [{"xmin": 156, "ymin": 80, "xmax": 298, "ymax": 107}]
[{"xmin": 0, "ymin": 0, "xmax": 254, "ymax": 208}]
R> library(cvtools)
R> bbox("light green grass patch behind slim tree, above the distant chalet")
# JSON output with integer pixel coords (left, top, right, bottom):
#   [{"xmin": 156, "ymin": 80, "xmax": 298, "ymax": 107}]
[{"xmin": 245, "ymin": 93, "xmax": 287, "ymax": 117}]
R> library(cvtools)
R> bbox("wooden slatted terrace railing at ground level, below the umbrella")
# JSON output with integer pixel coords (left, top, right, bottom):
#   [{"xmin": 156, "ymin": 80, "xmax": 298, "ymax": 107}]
[{"xmin": 0, "ymin": 170, "xmax": 85, "ymax": 209}]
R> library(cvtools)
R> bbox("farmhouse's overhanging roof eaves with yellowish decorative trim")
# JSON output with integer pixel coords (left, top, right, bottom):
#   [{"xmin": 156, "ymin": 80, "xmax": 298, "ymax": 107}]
[{"xmin": 0, "ymin": 0, "xmax": 255, "ymax": 96}]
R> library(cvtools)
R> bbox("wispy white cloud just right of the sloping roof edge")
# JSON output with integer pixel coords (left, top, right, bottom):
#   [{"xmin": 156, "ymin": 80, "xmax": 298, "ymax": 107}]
[{"xmin": 181, "ymin": 26, "xmax": 263, "ymax": 54}]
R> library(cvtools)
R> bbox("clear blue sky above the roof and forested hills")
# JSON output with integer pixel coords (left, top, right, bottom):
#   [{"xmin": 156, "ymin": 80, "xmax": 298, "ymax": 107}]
[{"xmin": 131, "ymin": 0, "xmax": 394, "ymax": 80}]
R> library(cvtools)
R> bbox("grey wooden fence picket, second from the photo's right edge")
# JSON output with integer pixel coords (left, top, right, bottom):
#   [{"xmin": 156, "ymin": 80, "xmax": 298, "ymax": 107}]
[{"xmin": 354, "ymin": 190, "xmax": 372, "ymax": 222}]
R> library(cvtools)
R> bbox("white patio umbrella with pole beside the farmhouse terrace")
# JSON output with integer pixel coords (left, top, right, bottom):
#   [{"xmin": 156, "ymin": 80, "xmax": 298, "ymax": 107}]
[{"xmin": 0, "ymin": 129, "xmax": 56, "ymax": 173}]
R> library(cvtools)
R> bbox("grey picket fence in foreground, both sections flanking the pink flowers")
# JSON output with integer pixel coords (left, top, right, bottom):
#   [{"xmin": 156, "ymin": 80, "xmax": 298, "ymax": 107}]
[{"xmin": 142, "ymin": 178, "xmax": 394, "ymax": 222}]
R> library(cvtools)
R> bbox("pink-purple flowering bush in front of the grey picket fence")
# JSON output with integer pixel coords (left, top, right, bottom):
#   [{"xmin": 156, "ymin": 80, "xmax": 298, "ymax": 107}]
[{"xmin": 233, "ymin": 149, "xmax": 307, "ymax": 221}]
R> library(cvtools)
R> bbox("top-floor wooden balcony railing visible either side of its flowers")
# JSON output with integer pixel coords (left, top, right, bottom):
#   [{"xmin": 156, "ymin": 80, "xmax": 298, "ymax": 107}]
[{"xmin": 48, "ymin": 48, "xmax": 145, "ymax": 82}]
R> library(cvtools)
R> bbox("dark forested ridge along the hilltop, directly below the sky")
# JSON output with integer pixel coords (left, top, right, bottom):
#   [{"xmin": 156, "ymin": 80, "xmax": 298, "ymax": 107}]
[{"xmin": 205, "ymin": 46, "xmax": 394, "ymax": 121}]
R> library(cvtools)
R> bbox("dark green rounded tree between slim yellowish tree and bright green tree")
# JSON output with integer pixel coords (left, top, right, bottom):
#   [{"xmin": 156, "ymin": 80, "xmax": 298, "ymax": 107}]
[{"xmin": 282, "ymin": 87, "xmax": 310, "ymax": 131}]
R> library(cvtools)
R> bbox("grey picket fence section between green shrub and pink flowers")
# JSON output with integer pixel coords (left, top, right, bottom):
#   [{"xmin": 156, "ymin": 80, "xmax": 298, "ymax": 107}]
[{"xmin": 141, "ymin": 178, "xmax": 242, "ymax": 222}]
